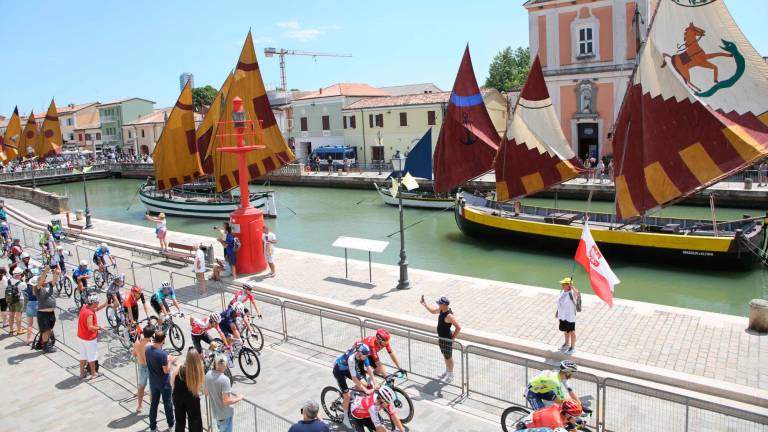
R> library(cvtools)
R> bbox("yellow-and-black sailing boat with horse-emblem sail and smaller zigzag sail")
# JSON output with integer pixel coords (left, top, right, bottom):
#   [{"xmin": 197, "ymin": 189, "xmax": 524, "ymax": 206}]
[{"xmin": 448, "ymin": 0, "xmax": 768, "ymax": 270}]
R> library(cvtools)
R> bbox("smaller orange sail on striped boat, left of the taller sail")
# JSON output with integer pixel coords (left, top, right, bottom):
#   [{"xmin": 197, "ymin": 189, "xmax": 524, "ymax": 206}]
[{"xmin": 152, "ymin": 81, "xmax": 203, "ymax": 190}]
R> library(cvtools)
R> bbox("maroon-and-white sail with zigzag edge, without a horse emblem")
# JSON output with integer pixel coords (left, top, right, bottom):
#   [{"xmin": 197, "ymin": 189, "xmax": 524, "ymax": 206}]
[{"xmin": 495, "ymin": 56, "xmax": 582, "ymax": 201}]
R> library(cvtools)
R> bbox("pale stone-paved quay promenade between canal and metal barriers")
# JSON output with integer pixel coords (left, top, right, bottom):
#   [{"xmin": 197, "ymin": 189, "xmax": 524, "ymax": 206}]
[{"xmin": 7, "ymin": 200, "xmax": 768, "ymax": 400}]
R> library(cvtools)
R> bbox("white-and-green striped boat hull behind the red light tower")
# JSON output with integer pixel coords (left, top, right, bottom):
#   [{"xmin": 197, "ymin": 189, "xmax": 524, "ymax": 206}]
[{"xmin": 139, "ymin": 185, "xmax": 277, "ymax": 219}]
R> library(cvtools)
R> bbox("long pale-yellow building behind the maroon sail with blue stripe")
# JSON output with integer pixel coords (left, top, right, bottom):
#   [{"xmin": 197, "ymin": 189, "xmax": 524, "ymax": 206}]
[{"xmin": 341, "ymin": 89, "xmax": 508, "ymax": 163}]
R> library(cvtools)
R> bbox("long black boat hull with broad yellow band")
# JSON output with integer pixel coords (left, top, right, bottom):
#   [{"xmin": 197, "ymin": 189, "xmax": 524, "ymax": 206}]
[{"xmin": 454, "ymin": 195, "xmax": 765, "ymax": 271}]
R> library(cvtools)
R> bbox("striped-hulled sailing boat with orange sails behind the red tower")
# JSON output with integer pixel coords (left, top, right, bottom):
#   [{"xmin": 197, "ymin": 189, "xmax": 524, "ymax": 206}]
[{"xmin": 139, "ymin": 32, "xmax": 293, "ymax": 218}]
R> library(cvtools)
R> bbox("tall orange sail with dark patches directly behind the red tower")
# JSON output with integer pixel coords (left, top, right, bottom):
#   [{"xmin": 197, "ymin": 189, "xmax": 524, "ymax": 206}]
[{"xmin": 213, "ymin": 31, "xmax": 295, "ymax": 190}]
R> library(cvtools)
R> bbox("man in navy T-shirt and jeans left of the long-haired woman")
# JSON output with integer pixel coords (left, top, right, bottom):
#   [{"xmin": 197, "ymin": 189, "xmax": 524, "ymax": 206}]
[{"xmin": 145, "ymin": 330, "xmax": 176, "ymax": 432}]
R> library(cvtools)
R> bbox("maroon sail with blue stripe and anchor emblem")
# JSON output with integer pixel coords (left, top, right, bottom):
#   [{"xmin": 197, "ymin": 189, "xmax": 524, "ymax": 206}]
[{"xmin": 433, "ymin": 45, "xmax": 500, "ymax": 192}]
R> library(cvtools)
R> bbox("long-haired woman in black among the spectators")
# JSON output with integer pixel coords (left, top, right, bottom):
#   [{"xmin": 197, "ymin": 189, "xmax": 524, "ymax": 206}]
[{"xmin": 171, "ymin": 349, "xmax": 205, "ymax": 432}]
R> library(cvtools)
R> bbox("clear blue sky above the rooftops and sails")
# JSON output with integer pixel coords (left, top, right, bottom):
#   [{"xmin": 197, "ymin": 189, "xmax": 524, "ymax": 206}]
[{"xmin": 0, "ymin": 0, "xmax": 768, "ymax": 115}]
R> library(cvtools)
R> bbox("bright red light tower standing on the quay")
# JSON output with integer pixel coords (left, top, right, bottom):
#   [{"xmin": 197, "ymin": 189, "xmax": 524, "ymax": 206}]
[{"xmin": 217, "ymin": 96, "xmax": 267, "ymax": 274}]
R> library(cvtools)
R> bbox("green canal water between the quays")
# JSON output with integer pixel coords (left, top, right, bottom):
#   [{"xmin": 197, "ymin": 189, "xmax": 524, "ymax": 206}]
[{"xmin": 43, "ymin": 180, "xmax": 768, "ymax": 316}]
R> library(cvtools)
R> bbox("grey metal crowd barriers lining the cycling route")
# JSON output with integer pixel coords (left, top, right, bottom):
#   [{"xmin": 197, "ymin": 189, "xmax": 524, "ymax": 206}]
[{"xmin": 10, "ymin": 224, "xmax": 768, "ymax": 432}]
